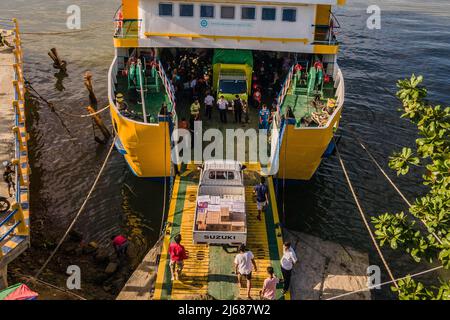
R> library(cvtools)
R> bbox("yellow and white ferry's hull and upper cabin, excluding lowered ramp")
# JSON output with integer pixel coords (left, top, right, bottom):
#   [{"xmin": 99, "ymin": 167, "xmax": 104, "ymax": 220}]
[{"xmin": 109, "ymin": 0, "xmax": 345, "ymax": 180}]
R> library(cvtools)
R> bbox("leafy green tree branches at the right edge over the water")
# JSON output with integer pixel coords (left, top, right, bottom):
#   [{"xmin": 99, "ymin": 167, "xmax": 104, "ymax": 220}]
[{"xmin": 372, "ymin": 75, "xmax": 450, "ymax": 300}]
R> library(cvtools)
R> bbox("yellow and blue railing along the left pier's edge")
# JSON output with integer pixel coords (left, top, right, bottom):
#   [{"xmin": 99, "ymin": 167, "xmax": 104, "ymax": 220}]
[{"xmin": 0, "ymin": 19, "xmax": 29, "ymax": 258}]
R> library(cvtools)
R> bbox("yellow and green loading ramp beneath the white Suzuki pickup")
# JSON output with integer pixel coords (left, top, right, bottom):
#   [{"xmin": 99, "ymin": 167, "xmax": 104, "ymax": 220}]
[{"xmin": 153, "ymin": 164, "xmax": 289, "ymax": 300}]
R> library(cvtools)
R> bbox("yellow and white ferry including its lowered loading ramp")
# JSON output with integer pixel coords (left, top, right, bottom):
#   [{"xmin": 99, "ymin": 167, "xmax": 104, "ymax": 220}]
[{"xmin": 108, "ymin": 0, "xmax": 345, "ymax": 299}]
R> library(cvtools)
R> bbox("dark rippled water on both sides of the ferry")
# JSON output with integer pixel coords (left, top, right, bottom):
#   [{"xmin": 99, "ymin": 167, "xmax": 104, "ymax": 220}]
[{"xmin": 0, "ymin": 0, "xmax": 450, "ymax": 298}]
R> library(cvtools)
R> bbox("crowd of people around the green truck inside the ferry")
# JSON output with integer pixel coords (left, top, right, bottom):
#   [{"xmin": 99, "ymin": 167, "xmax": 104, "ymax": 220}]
[{"xmin": 161, "ymin": 49, "xmax": 302, "ymax": 129}]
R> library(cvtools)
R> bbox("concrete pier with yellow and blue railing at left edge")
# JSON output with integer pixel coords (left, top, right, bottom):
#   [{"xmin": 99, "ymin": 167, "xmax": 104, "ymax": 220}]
[{"xmin": 0, "ymin": 19, "xmax": 30, "ymax": 289}]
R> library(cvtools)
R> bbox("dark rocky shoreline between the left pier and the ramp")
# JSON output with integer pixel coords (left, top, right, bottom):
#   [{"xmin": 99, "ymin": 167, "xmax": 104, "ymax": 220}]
[{"xmin": 8, "ymin": 228, "xmax": 136, "ymax": 300}]
